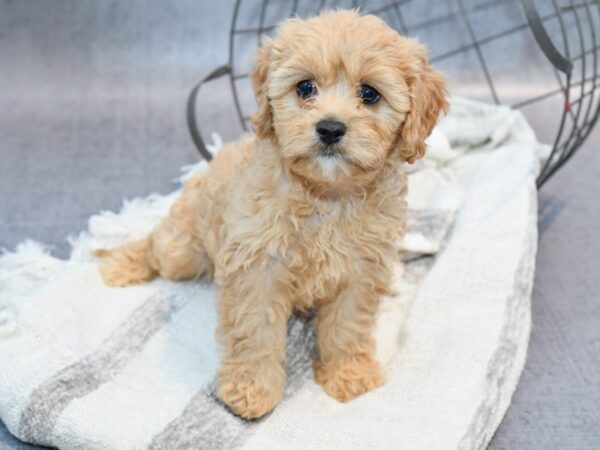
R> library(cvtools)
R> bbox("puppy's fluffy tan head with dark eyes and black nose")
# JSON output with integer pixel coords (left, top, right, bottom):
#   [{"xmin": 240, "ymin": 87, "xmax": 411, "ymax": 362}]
[{"xmin": 252, "ymin": 11, "xmax": 448, "ymax": 187}]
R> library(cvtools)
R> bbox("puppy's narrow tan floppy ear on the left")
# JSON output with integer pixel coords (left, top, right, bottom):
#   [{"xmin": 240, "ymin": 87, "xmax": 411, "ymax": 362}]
[{"xmin": 250, "ymin": 39, "xmax": 274, "ymax": 139}]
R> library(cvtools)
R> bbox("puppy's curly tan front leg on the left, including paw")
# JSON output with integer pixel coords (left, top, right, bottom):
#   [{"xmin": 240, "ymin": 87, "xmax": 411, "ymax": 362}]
[{"xmin": 217, "ymin": 264, "xmax": 291, "ymax": 419}]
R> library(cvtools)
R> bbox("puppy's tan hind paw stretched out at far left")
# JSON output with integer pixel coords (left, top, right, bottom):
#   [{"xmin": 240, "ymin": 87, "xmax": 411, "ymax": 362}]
[{"xmin": 94, "ymin": 237, "xmax": 158, "ymax": 286}]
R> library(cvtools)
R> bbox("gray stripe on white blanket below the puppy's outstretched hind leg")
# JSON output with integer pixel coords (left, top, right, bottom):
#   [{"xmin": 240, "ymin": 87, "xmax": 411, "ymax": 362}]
[{"xmin": 19, "ymin": 293, "xmax": 176, "ymax": 445}]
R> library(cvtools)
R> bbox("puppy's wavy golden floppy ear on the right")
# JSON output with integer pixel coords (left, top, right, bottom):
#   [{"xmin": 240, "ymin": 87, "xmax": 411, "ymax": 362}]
[{"xmin": 400, "ymin": 42, "xmax": 448, "ymax": 163}]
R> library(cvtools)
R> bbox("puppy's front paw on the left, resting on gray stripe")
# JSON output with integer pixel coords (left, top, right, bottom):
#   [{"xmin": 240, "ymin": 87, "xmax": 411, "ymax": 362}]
[{"xmin": 217, "ymin": 366, "xmax": 285, "ymax": 419}]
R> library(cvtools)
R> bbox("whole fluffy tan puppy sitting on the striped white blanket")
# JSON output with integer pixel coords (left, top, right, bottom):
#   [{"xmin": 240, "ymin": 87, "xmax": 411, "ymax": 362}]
[{"xmin": 100, "ymin": 11, "xmax": 447, "ymax": 418}]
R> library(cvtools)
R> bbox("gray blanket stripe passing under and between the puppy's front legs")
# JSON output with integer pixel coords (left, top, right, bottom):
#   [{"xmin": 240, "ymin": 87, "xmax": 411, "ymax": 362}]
[{"xmin": 149, "ymin": 318, "xmax": 315, "ymax": 450}]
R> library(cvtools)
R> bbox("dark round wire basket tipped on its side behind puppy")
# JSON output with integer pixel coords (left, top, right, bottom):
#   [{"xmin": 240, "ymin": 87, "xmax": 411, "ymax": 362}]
[{"xmin": 188, "ymin": 0, "xmax": 600, "ymax": 187}]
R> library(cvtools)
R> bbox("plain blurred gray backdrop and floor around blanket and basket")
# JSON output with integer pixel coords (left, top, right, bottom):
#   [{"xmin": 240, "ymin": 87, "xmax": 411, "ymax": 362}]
[{"xmin": 0, "ymin": 0, "xmax": 600, "ymax": 449}]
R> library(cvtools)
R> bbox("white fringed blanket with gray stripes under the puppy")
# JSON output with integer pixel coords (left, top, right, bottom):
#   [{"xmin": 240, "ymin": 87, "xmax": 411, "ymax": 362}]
[{"xmin": 0, "ymin": 99, "xmax": 542, "ymax": 450}]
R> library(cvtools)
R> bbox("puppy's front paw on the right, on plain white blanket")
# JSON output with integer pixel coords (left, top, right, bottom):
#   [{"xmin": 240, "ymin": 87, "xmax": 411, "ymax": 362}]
[{"xmin": 314, "ymin": 356, "xmax": 385, "ymax": 402}]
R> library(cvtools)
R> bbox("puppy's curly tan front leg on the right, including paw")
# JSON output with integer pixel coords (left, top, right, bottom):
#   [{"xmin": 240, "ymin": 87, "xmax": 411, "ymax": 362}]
[{"xmin": 314, "ymin": 274, "xmax": 384, "ymax": 402}]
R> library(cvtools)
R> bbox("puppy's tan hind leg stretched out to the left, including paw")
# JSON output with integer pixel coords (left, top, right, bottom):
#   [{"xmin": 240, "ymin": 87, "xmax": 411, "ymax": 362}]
[{"xmin": 96, "ymin": 177, "xmax": 213, "ymax": 286}]
